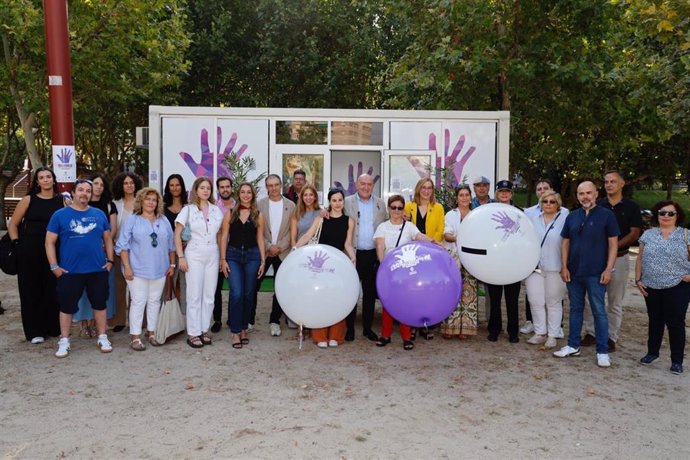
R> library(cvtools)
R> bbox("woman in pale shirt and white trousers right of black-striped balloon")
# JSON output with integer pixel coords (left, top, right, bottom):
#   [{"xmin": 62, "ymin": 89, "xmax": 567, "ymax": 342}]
[{"xmin": 525, "ymin": 191, "xmax": 568, "ymax": 348}]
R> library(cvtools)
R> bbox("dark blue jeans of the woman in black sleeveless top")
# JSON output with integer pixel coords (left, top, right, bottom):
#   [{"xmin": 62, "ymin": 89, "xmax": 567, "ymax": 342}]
[{"xmin": 225, "ymin": 246, "xmax": 261, "ymax": 334}]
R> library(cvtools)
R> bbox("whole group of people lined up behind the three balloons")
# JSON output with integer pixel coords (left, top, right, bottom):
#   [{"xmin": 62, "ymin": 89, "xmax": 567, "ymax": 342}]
[{"xmin": 9, "ymin": 168, "xmax": 690, "ymax": 373}]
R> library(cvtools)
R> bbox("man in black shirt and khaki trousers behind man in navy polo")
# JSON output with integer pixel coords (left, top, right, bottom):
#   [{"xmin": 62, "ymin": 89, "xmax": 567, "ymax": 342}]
[{"xmin": 580, "ymin": 170, "xmax": 644, "ymax": 352}]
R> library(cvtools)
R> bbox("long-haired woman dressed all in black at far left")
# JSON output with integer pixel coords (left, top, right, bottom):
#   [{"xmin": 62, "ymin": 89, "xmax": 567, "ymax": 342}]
[{"xmin": 7, "ymin": 167, "xmax": 63, "ymax": 344}]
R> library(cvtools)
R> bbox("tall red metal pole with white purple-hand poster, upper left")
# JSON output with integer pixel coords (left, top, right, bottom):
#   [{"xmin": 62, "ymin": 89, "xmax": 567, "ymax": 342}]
[{"xmin": 43, "ymin": 0, "xmax": 77, "ymax": 192}]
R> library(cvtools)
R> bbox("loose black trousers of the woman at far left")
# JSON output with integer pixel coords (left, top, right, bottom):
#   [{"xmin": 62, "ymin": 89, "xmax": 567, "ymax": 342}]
[{"xmin": 17, "ymin": 236, "xmax": 60, "ymax": 340}]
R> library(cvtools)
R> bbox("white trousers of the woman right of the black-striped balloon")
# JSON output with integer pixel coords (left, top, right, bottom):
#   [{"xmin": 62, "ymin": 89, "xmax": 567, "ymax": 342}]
[{"xmin": 525, "ymin": 271, "xmax": 565, "ymax": 337}]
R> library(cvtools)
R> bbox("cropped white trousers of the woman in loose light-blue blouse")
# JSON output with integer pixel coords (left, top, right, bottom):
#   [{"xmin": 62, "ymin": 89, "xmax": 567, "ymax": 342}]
[{"xmin": 126, "ymin": 276, "xmax": 165, "ymax": 335}]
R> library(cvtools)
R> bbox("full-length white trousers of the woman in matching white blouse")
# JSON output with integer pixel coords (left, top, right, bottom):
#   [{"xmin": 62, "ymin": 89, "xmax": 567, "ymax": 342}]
[{"xmin": 184, "ymin": 241, "xmax": 220, "ymax": 336}]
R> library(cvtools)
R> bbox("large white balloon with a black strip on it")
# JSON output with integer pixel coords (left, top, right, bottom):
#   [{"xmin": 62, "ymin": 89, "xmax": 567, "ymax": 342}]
[{"xmin": 458, "ymin": 203, "xmax": 541, "ymax": 285}]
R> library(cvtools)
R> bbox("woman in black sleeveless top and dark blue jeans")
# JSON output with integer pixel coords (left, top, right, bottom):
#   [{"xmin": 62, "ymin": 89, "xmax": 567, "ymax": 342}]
[{"xmin": 220, "ymin": 182, "xmax": 266, "ymax": 349}]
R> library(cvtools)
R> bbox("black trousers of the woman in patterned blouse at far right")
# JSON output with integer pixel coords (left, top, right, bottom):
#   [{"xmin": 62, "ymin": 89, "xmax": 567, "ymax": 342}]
[{"xmin": 644, "ymin": 281, "xmax": 690, "ymax": 364}]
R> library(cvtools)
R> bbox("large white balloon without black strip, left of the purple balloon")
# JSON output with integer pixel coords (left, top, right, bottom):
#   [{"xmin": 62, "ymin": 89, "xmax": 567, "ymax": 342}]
[{"xmin": 275, "ymin": 244, "xmax": 359, "ymax": 328}]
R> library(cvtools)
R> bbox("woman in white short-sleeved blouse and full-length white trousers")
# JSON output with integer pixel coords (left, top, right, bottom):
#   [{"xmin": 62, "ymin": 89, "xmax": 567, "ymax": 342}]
[{"xmin": 175, "ymin": 177, "xmax": 223, "ymax": 348}]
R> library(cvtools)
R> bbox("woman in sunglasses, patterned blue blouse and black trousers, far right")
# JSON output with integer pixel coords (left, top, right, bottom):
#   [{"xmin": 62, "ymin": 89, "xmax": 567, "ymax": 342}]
[{"xmin": 635, "ymin": 201, "xmax": 690, "ymax": 374}]
